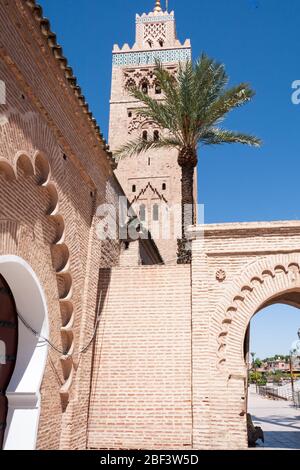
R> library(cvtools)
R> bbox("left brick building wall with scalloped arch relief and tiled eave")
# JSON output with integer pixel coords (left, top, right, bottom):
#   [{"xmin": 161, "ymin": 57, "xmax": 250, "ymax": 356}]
[{"xmin": 0, "ymin": 0, "xmax": 164, "ymax": 449}]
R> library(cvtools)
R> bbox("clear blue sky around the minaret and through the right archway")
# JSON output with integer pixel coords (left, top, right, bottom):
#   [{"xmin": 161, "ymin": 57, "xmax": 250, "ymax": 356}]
[{"xmin": 40, "ymin": 0, "xmax": 300, "ymax": 355}]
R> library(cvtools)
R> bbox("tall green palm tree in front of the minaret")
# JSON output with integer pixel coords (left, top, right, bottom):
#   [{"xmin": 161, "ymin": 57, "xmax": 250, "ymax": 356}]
[{"xmin": 115, "ymin": 54, "xmax": 261, "ymax": 262}]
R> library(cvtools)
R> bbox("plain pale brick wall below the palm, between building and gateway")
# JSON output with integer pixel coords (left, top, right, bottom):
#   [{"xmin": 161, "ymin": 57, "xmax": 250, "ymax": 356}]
[{"xmin": 88, "ymin": 266, "xmax": 192, "ymax": 449}]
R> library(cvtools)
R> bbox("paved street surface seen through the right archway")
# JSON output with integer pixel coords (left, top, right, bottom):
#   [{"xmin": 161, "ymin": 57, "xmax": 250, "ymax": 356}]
[{"xmin": 248, "ymin": 389, "xmax": 300, "ymax": 449}]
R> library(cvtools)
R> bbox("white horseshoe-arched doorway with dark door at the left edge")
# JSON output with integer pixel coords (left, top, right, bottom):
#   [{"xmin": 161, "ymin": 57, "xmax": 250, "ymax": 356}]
[{"xmin": 0, "ymin": 255, "xmax": 48, "ymax": 450}]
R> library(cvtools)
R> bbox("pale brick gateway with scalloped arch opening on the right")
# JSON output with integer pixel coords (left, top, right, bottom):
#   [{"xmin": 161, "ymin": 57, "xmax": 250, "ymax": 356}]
[{"xmin": 192, "ymin": 221, "xmax": 300, "ymax": 449}]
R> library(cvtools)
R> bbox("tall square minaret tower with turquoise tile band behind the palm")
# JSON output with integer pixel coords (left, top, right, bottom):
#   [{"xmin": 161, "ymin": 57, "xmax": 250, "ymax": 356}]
[{"xmin": 109, "ymin": 0, "xmax": 191, "ymax": 264}]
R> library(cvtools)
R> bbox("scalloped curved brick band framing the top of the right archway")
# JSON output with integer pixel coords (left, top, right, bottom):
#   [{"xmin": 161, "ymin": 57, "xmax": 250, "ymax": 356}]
[{"xmin": 217, "ymin": 254, "xmax": 300, "ymax": 374}]
